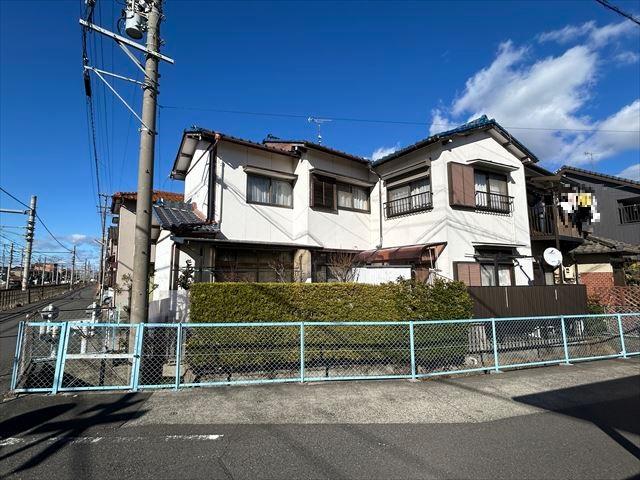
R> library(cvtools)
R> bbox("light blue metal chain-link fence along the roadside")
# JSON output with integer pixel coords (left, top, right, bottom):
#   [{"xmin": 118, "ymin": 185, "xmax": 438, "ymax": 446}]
[{"xmin": 11, "ymin": 312, "xmax": 640, "ymax": 393}]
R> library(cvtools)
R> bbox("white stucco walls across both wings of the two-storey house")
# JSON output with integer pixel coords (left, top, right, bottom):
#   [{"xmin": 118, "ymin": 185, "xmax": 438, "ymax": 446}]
[{"xmin": 174, "ymin": 132, "xmax": 533, "ymax": 285}]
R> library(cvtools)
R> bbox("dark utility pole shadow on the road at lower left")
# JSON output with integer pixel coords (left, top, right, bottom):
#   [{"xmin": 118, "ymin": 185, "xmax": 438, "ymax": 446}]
[{"xmin": 0, "ymin": 393, "xmax": 147, "ymax": 474}]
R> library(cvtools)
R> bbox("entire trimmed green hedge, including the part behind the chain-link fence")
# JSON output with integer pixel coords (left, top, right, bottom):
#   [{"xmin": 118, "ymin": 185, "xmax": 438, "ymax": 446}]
[{"xmin": 185, "ymin": 281, "xmax": 472, "ymax": 372}]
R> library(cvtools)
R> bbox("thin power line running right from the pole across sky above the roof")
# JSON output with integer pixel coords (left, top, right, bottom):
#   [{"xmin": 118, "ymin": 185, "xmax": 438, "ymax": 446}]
[{"xmin": 158, "ymin": 105, "xmax": 640, "ymax": 133}]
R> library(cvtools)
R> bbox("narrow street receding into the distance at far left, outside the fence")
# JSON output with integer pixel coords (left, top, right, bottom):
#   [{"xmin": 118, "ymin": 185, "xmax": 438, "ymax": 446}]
[{"xmin": 0, "ymin": 286, "xmax": 95, "ymax": 397}]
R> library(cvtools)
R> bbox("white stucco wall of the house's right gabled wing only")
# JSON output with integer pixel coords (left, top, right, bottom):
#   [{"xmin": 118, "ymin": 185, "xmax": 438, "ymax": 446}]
[{"xmin": 380, "ymin": 133, "xmax": 533, "ymax": 285}]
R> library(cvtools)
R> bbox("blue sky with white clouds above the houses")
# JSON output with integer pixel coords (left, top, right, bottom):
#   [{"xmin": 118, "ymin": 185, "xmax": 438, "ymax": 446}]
[{"xmin": 0, "ymin": 0, "xmax": 640, "ymax": 266}]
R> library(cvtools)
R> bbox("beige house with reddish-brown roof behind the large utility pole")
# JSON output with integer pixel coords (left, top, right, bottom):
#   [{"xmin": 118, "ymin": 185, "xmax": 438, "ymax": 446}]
[{"xmin": 105, "ymin": 191, "xmax": 183, "ymax": 307}]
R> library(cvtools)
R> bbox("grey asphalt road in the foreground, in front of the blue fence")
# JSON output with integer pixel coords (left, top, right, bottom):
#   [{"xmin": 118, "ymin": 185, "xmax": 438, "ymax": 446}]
[{"xmin": 0, "ymin": 360, "xmax": 640, "ymax": 480}]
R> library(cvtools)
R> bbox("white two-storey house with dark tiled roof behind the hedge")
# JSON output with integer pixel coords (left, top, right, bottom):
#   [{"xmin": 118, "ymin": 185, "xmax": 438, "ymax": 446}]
[{"xmin": 152, "ymin": 117, "xmax": 548, "ymax": 295}]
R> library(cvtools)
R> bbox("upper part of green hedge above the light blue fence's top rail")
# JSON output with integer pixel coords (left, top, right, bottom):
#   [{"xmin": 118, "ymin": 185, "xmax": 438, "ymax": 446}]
[{"xmin": 190, "ymin": 281, "xmax": 473, "ymax": 323}]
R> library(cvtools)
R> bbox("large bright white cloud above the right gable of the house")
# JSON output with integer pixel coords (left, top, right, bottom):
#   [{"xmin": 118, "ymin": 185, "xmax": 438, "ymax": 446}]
[{"xmin": 431, "ymin": 22, "xmax": 640, "ymax": 169}]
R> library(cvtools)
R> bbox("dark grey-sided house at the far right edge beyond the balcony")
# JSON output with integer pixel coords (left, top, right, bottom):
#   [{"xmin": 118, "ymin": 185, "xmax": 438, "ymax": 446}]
[{"xmin": 558, "ymin": 166, "xmax": 640, "ymax": 245}]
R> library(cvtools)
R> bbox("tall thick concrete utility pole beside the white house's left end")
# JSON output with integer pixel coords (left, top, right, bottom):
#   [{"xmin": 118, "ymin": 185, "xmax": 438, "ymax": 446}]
[{"xmin": 131, "ymin": 0, "xmax": 162, "ymax": 323}]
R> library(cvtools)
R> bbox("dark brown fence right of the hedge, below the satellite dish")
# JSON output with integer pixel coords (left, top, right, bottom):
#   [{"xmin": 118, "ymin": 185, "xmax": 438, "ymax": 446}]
[{"xmin": 468, "ymin": 285, "xmax": 588, "ymax": 318}]
